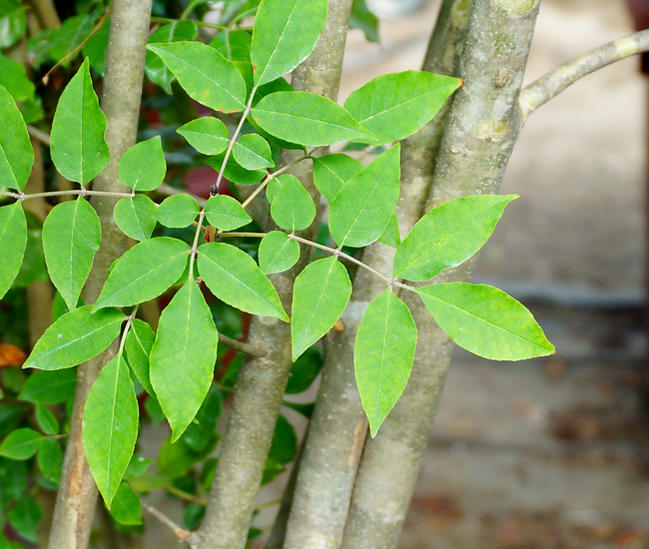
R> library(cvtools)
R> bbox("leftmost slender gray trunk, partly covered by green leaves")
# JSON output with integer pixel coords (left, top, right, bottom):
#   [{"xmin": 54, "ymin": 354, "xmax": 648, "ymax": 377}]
[{"xmin": 49, "ymin": 0, "xmax": 151, "ymax": 549}]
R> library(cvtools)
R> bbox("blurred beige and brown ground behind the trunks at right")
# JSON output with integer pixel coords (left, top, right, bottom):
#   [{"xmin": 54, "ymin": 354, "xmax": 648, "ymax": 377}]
[{"xmin": 334, "ymin": 0, "xmax": 649, "ymax": 549}]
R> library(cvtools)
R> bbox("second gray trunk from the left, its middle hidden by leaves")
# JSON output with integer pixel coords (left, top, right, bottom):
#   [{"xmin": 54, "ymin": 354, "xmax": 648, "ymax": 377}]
[{"xmin": 196, "ymin": 0, "xmax": 351, "ymax": 549}]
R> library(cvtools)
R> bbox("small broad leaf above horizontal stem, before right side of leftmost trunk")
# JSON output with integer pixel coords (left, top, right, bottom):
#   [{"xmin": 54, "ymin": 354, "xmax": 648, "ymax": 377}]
[{"xmin": 119, "ymin": 135, "xmax": 167, "ymax": 191}]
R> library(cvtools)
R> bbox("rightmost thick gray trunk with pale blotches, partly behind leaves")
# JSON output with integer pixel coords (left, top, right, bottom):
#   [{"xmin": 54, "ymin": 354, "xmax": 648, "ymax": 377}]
[{"xmin": 343, "ymin": 0, "xmax": 538, "ymax": 549}]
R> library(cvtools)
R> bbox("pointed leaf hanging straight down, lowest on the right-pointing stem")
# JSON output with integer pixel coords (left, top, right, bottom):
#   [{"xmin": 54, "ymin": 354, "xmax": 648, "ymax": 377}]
[{"xmin": 354, "ymin": 288, "xmax": 417, "ymax": 437}]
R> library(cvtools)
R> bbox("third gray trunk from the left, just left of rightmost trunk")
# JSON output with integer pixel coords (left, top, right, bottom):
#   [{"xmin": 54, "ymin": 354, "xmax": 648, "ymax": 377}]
[{"xmin": 285, "ymin": 0, "xmax": 470, "ymax": 549}]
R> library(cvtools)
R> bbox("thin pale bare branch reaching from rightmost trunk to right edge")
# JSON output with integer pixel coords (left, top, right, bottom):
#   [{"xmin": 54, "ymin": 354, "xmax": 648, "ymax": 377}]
[{"xmin": 519, "ymin": 29, "xmax": 649, "ymax": 119}]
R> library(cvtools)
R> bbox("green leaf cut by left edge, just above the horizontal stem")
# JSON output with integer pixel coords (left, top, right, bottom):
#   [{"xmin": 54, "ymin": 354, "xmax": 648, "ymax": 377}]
[{"xmin": 0, "ymin": 86, "xmax": 34, "ymax": 191}]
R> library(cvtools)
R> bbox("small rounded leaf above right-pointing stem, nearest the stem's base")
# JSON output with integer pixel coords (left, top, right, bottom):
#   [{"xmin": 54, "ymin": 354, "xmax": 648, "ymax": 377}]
[{"xmin": 270, "ymin": 174, "xmax": 316, "ymax": 232}]
